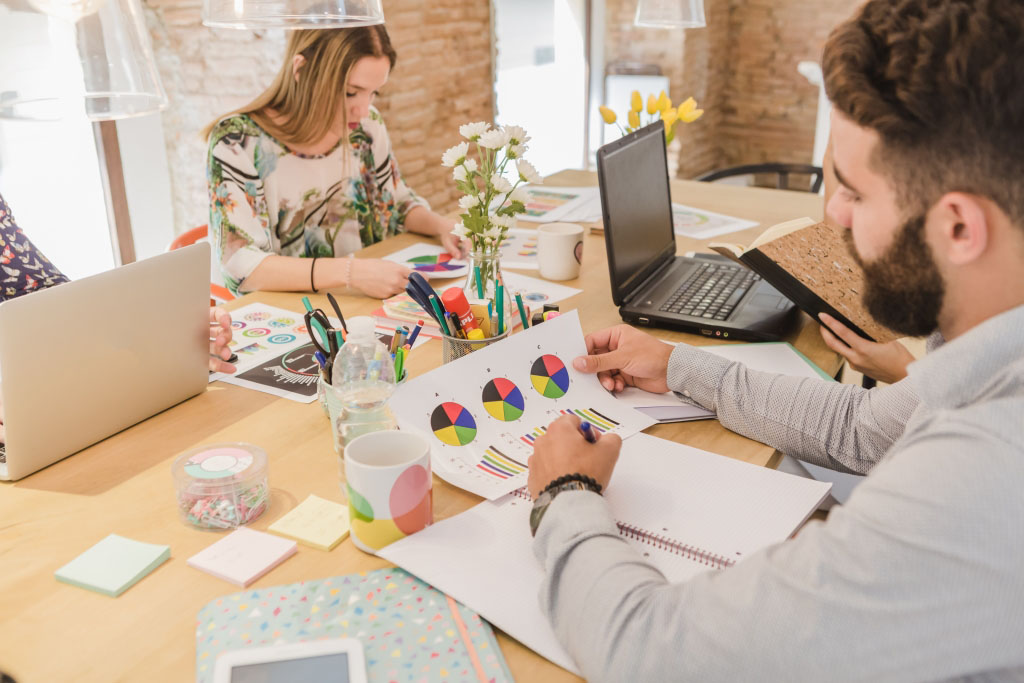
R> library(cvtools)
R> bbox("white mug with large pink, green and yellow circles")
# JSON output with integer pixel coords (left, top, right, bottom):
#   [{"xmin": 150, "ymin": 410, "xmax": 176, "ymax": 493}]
[{"xmin": 343, "ymin": 430, "xmax": 434, "ymax": 553}]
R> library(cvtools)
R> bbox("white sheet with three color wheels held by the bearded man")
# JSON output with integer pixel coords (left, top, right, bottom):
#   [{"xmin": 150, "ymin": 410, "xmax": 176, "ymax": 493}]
[{"xmin": 390, "ymin": 310, "xmax": 654, "ymax": 500}]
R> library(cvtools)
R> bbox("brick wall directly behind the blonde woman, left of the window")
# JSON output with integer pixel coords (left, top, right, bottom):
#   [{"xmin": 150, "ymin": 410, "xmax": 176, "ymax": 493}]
[{"xmin": 144, "ymin": 0, "xmax": 494, "ymax": 232}]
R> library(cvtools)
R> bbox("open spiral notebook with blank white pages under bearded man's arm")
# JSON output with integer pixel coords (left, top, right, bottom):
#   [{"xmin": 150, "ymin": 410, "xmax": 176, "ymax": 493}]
[{"xmin": 378, "ymin": 434, "xmax": 829, "ymax": 674}]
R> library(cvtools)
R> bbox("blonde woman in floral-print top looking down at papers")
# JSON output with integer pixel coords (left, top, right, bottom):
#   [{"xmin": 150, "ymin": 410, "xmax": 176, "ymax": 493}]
[{"xmin": 204, "ymin": 26, "xmax": 460, "ymax": 298}]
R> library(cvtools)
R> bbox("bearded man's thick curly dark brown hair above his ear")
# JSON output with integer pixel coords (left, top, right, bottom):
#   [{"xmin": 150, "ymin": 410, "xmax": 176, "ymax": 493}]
[{"xmin": 823, "ymin": 0, "xmax": 1024, "ymax": 227}]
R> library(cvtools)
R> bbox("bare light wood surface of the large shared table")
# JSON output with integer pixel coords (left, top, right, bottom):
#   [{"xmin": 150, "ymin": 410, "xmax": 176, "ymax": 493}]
[{"xmin": 0, "ymin": 172, "xmax": 839, "ymax": 683}]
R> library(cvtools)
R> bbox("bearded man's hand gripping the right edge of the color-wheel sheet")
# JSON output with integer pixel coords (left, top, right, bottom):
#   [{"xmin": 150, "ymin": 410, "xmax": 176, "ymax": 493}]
[{"xmin": 572, "ymin": 325, "xmax": 673, "ymax": 393}]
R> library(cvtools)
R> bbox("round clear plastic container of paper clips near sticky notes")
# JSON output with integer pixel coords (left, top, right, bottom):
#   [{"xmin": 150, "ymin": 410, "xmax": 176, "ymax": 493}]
[{"xmin": 171, "ymin": 442, "xmax": 270, "ymax": 531}]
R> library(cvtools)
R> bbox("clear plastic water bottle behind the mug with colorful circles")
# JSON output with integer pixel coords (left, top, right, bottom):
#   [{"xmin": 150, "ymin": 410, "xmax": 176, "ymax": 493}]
[{"xmin": 330, "ymin": 316, "xmax": 398, "ymax": 455}]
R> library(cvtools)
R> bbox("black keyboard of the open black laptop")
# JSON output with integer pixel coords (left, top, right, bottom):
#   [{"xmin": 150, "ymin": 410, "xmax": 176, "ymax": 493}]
[{"xmin": 659, "ymin": 263, "xmax": 761, "ymax": 321}]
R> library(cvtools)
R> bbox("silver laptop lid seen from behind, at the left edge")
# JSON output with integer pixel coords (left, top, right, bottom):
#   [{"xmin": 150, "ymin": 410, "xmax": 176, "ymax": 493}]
[{"xmin": 0, "ymin": 243, "xmax": 210, "ymax": 479}]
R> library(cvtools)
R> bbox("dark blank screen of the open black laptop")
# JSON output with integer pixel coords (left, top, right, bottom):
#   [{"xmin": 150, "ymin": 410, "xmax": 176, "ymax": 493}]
[{"xmin": 597, "ymin": 121, "xmax": 676, "ymax": 305}]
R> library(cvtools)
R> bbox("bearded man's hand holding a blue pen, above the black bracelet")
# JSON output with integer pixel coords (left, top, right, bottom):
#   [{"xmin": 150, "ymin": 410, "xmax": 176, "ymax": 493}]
[{"xmin": 527, "ymin": 415, "xmax": 623, "ymax": 499}]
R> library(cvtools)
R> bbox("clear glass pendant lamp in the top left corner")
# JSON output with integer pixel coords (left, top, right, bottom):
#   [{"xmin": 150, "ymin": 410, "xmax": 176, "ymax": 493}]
[{"xmin": 0, "ymin": 0, "xmax": 167, "ymax": 121}]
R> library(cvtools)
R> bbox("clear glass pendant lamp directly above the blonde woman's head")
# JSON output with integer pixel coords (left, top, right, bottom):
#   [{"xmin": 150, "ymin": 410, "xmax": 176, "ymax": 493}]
[{"xmin": 203, "ymin": 0, "xmax": 384, "ymax": 29}]
